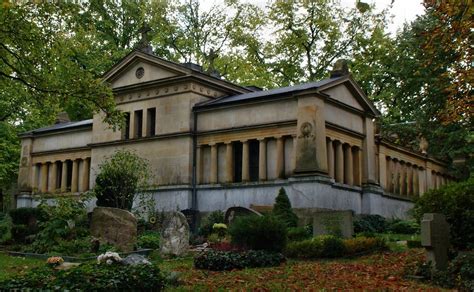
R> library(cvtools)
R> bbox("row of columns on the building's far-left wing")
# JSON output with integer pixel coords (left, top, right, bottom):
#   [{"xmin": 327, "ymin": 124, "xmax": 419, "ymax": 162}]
[{"xmin": 31, "ymin": 158, "xmax": 90, "ymax": 193}]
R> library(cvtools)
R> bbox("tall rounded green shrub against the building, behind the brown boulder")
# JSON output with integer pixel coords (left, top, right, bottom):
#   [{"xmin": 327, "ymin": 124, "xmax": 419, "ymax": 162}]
[{"xmin": 92, "ymin": 150, "xmax": 151, "ymax": 211}]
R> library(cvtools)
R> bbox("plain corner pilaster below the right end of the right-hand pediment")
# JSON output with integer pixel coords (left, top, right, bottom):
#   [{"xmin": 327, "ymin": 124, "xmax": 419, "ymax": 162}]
[{"xmin": 362, "ymin": 118, "xmax": 377, "ymax": 184}]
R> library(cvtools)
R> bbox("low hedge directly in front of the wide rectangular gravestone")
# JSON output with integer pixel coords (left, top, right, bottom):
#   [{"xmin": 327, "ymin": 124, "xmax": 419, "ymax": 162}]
[{"xmin": 285, "ymin": 235, "xmax": 387, "ymax": 259}]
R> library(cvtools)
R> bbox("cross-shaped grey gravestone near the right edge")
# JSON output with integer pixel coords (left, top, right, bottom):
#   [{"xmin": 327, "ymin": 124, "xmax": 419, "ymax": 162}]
[{"xmin": 421, "ymin": 213, "xmax": 449, "ymax": 270}]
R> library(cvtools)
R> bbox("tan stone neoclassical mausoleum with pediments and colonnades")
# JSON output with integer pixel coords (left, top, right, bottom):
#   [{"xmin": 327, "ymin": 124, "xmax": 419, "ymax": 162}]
[{"xmin": 17, "ymin": 51, "xmax": 449, "ymax": 217}]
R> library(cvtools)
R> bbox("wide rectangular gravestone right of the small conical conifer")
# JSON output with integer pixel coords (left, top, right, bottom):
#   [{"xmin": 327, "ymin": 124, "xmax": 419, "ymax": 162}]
[{"xmin": 313, "ymin": 210, "xmax": 354, "ymax": 238}]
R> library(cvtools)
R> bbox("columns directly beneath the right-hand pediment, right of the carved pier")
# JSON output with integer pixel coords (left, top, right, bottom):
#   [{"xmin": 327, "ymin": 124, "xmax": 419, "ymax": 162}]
[{"xmin": 326, "ymin": 138, "xmax": 362, "ymax": 186}]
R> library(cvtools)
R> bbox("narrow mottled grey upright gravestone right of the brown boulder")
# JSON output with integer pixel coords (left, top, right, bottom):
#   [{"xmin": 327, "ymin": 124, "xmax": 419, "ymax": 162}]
[{"xmin": 160, "ymin": 212, "xmax": 189, "ymax": 256}]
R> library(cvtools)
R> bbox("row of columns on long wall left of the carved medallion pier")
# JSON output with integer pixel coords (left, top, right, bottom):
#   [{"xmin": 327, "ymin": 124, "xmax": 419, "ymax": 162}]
[{"xmin": 196, "ymin": 136, "xmax": 294, "ymax": 184}]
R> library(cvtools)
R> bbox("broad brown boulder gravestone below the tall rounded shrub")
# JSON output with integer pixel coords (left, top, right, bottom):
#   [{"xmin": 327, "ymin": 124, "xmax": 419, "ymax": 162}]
[{"xmin": 90, "ymin": 207, "xmax": 137, "ymax": 252}]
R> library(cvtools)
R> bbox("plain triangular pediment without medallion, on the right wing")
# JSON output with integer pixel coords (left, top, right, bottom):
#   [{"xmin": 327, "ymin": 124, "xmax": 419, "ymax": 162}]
[{"xmin": 320, "ymin": 76, "xmax": 380, "ymax": 116}]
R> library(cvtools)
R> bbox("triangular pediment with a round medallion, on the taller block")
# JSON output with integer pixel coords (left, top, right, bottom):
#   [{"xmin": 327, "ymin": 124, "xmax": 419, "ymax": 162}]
[{"xmin": 103, "ymin": 51, "xmax": 187, "ymax": 88}]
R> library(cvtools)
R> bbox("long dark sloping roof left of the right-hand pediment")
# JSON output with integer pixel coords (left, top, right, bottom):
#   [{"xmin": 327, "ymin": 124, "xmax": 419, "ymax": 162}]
[{"xmin": 195, "ymin": 77, "xmax": 344, "ymax": 108}]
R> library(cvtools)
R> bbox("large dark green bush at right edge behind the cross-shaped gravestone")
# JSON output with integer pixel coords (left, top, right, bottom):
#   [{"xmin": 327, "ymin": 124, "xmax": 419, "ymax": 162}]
[{"xmin": 413, "ymin": 176, "xmax": 474, "ymax": 249}]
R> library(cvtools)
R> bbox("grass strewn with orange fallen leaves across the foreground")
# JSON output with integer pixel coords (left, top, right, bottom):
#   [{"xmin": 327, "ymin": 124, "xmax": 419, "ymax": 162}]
[{"xmin": 161, "ymin": 249, "xmax": 446, "ymax": 291}]
